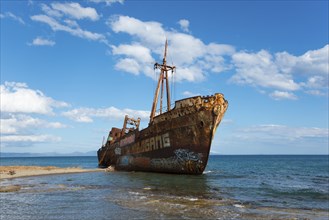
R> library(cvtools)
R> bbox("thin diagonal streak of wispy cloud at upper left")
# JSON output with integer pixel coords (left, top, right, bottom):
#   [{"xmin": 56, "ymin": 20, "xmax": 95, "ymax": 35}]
[{"xmin": 31, "ymin": 15, "xmax": 107, "ymax": 44}]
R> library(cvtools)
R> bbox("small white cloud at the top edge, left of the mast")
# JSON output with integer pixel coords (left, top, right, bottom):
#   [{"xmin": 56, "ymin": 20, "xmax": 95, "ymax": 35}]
[{"xmin": 51, "ymin": 2, "xmax": 99, "ymax": 21}]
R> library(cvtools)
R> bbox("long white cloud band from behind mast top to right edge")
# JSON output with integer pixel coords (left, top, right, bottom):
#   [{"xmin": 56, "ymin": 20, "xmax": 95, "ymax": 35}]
[{"xmin": 107, "ymin": 16, "xmax": 329, "ymax": 100}]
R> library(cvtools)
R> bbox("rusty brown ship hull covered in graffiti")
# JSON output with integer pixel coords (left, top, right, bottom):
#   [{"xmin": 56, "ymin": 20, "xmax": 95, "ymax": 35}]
[{"xmin": 97, "ymin": 93, "xmax": 228, "ymax": 174}]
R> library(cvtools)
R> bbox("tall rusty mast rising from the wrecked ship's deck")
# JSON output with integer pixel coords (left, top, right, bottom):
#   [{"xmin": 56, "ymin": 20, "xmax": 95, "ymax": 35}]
[{"xmin": 150, "ymin": 40, "xmax": 176, "ymax": 123}]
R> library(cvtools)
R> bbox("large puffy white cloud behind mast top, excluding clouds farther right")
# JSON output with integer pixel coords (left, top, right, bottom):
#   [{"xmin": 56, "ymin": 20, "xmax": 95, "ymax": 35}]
[{"xmin": 107, "ymin": 16, "xmax": 235, "ymax": 82}]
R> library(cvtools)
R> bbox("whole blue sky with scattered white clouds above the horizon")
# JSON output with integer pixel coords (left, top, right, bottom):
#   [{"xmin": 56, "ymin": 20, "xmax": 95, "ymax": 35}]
[{"xmin": 0, "ymin": 0, "xmax": 329, "ymax": 154}]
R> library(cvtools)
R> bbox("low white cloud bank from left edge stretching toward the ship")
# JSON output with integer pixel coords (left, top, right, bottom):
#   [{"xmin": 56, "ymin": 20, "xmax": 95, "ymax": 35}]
[{"xmin": 0, "ymin": 82, "xmax": 150, "ymax": 147}]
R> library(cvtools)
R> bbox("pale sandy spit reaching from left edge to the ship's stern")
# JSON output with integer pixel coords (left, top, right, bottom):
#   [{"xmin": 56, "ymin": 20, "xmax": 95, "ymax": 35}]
[{"xmin": 0, "ymin": 166, "xmax": 104, "ymax": 181}]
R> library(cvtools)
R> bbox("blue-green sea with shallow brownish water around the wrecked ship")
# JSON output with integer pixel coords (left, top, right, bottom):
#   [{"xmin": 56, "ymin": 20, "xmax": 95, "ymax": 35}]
[{"xmin": 0, "ymin": 155, "xmax": 329, "ymax": 220}]
